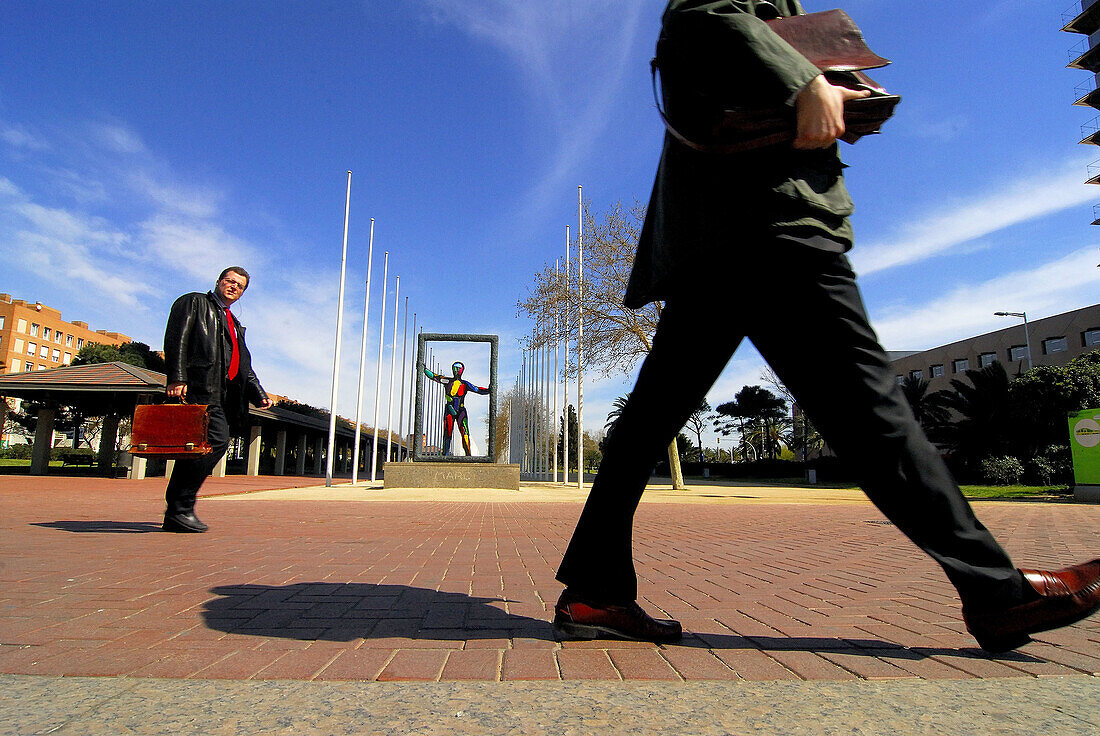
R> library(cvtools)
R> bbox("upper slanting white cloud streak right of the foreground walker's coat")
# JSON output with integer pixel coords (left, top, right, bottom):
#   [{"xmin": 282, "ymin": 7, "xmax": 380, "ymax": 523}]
[{"xmin": 851, "ymin": 161, "xmax": 1097, "ymax": 276}]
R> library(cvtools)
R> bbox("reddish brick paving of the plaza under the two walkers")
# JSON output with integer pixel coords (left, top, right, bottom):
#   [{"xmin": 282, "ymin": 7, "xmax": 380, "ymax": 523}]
[{"xmin": 0, "ymin": 475, "xmax": 1100, "ymax": 681}]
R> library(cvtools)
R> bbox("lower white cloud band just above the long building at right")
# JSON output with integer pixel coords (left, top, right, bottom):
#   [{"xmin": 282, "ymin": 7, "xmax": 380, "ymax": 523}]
[{"xmin": 875, "ymin": 246, "xmax": 1100, "ymax": 350}]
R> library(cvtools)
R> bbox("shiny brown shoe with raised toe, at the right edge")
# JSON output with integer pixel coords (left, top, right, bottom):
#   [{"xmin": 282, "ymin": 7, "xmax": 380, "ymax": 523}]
[{"xmin": 963, "ymin": 559, "xmax": 1100, "ymax": 652}]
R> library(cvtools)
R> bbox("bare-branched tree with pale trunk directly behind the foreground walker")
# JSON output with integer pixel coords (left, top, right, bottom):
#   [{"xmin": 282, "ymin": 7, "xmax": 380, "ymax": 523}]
[{"xmin": 517, "ymin": 200, "xmax": 684, "ymax": 488}]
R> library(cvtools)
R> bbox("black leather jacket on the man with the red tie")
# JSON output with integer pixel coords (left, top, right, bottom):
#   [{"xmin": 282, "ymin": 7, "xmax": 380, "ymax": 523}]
[{"xmin": 164, "ymin": 292, "xmax": 267, "ymax": 417}]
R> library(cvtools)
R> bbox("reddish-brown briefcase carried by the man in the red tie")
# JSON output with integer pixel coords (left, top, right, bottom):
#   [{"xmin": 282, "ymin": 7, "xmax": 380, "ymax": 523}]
[{"xmin": 130, "ymin": 404, "xmax": 212, "ymax": 460}]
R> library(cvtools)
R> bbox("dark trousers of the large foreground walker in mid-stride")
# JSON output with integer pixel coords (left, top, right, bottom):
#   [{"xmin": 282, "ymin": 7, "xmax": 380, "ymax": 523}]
[{"xmin": 558, "ymin": 246, "xmax": 1022, "ymax": 605}]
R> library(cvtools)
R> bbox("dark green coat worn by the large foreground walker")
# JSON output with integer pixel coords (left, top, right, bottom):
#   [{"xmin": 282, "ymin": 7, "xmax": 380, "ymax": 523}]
[{"xmin": 624, "ymin": 0, "xmax": 853, "ymax": 308}]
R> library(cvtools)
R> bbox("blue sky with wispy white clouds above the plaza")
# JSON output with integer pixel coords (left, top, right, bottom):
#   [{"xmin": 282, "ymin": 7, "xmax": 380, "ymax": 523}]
[{"xmin": 0, "ymin": 0, "xmax": 1100, "ymax": 453}]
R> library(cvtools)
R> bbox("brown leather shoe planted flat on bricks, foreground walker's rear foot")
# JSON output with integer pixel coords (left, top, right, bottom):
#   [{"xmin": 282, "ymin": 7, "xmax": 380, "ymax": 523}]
[{"xmin": 553, "ymin": 589, "xmax": 683, "ymax": 642}]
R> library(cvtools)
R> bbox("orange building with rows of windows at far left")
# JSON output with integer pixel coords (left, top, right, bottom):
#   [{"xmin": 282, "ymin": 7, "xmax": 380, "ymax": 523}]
[{"xmin": 0, "ymin": 294, "xmax": 130, "ymax": 374}]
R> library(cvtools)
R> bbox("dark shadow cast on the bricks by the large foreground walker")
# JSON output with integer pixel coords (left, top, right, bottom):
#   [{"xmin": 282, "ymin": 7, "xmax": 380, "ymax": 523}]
[{"xmin": 202, "ymin": 582, "xmax": 1042, "ymax": 662}]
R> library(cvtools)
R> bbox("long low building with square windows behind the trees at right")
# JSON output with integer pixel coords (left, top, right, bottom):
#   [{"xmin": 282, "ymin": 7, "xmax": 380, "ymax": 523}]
[{"xmin": 889, "ymin": 304, "xmax": 1100, "ymax": 392}]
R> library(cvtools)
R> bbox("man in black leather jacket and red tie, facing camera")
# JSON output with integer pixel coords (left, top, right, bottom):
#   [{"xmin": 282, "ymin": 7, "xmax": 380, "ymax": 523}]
[{"xmin": 163, "ymin": 266, "xmax": 271, "ymax": 532}]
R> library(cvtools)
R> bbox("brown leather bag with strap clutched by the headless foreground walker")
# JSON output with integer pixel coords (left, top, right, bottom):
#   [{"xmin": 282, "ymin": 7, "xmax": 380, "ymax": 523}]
[{"xmin": 652, "ymin": 10, "xmax": 901, "ymax": 153}]
